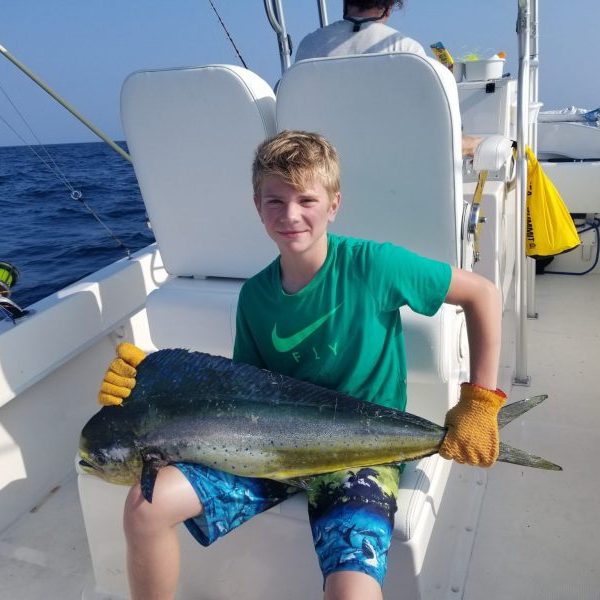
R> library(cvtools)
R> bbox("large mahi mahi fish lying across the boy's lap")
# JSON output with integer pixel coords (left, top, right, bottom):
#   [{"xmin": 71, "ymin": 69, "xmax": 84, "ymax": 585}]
[{"xmin": 79, "ymin": 349, "xmax": 561, "ymax": 502}]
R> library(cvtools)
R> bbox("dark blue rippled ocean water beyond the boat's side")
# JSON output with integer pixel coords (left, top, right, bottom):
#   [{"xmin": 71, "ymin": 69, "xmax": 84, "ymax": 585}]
[{"xmin": 0, "ymin": 142, "xmax": 154, "ymax": 307}]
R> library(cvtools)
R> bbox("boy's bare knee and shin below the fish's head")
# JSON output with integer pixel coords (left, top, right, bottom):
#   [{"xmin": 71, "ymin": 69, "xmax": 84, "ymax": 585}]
[{"xmin": 123, "ymin": 467, "xmax": 202, "ymax": 600}]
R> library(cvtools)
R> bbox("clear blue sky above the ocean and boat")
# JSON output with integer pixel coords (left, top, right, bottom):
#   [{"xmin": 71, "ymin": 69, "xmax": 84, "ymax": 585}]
[{"xmin": 0, "ymin": 0, "xmax": 600, "ymax": 145}]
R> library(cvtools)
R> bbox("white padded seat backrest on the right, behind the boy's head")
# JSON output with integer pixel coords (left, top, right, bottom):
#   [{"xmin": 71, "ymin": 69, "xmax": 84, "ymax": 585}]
[{"xmin": 277, "ymin": 53, "xmax": 463, "ymax": 265}]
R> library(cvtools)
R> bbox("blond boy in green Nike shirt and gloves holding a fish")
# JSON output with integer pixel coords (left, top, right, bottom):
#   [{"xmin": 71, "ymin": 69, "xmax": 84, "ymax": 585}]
[{"xmin": 100, "ymin": 131, "xmax": 504, "ymax": 600}]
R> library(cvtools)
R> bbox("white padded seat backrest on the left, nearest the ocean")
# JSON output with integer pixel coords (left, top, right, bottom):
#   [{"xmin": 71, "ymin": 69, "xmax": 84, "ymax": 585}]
[{"xmin": 121, "ymin": 65, "xmax": 276, "ymax": 278}]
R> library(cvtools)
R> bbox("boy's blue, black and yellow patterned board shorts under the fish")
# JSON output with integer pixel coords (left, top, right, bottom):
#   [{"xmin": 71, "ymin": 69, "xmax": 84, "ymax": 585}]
[{"xmin": 175, "ymin": 463, "xmax": 401, "ymax": 585}]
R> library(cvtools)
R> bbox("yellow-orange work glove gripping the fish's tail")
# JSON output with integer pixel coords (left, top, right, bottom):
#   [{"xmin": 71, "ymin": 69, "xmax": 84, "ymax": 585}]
[{"xmin": 440, "ymin": 383, "xmax": 506, "ymax": 467}]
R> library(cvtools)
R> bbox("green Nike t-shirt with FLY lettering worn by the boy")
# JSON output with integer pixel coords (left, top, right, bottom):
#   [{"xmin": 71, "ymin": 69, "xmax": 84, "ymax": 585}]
[{"xmin": 233, "ymin": 234, "xmax": 451, "ymax": 410}]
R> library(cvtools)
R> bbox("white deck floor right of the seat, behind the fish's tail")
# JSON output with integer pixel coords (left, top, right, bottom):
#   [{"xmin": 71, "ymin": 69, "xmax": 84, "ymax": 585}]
[{"xmin": 459, "ymin": 275, "xmax": 600, "ymax": 600}]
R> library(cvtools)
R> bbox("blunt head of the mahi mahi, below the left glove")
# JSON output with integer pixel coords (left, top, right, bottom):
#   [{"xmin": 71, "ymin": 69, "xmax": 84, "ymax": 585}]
[{"xmin": 79, "ymin": 406, "xmax": 142, "ymax": 485}]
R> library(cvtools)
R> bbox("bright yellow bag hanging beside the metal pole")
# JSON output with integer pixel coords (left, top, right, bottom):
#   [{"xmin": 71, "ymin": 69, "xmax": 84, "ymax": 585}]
[{"xmin": 525, "ymin": 146, "xmax": 581, "ymax": 257}]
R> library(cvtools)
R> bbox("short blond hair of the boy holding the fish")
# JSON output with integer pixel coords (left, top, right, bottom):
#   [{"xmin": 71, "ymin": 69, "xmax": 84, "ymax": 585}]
[{"xmin": 252, "ymin": 131, "xmax": 340, "ymax": 198}]
